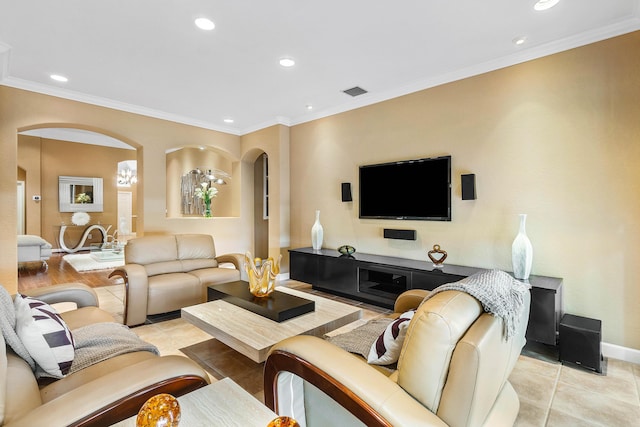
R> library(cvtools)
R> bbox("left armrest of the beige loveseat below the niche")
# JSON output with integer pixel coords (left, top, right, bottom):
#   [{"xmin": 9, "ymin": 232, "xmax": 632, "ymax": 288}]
[{"xmin": 109, "ymin": 264, "xmax": 149, "ymax": 326}]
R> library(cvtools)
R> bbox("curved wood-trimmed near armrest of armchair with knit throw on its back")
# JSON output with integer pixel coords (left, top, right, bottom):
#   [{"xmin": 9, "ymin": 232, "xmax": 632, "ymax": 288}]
[{"xmin": 264, "ymin": 335, "xmax": 446, "ymax": 427}]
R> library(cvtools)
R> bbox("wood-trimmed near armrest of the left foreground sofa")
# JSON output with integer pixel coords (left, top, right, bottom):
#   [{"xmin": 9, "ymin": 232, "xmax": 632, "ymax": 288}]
[{"xmin": 11, "ymin": 356, "xmax": 209, "ymax": 427}]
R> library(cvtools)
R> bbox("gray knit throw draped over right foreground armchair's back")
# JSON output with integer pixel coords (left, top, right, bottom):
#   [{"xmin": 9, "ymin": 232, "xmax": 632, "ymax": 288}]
[{"xmin": 423, "ymin": 270, "xmax": 531, "ymax": 339}]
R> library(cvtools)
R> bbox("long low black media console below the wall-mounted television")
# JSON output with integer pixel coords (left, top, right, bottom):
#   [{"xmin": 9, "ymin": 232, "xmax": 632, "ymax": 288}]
[{"xmin": 289, "ymin": 248, "xmax": 563, "ymax": 345}]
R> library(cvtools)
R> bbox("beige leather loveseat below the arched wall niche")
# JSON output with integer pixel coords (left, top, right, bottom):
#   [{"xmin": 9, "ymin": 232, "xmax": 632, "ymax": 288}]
[{"xmin": 109, "ymin": 234, "xmax": 244, "ymax": 326}]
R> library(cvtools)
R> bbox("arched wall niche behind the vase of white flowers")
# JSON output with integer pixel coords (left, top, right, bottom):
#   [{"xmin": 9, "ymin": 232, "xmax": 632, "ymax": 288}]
[{"xmin": 166, "ymin": 145, "xmax": 242, "ymax": 219}]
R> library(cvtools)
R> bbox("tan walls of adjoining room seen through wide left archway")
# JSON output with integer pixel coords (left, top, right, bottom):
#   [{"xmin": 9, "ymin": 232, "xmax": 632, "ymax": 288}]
[{"xmin": 16, "ymin": 122, "xmax": 144, "ymax": 249}]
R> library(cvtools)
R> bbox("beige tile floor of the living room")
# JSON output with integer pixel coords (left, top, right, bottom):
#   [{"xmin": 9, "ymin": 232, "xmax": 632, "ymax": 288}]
[{"xmin": 95, "ymin": 281, "xmax": 640, "ymax": 427}]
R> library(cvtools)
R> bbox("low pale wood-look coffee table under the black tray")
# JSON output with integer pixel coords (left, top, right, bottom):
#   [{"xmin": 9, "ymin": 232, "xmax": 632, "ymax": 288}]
[{"xmin": 182, "ymin": 282, "xmax": 362, "ymax": 363}]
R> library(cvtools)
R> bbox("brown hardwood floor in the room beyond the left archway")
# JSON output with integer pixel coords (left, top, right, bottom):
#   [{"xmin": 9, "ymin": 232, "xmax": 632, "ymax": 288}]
[{"xmin": 18, "ymin": 252, "xmax": 122, "ymax": 291}]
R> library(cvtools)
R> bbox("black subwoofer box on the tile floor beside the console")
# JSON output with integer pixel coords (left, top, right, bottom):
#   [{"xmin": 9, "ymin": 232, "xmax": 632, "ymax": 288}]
[{"xmin": 559, "ymin": 314, "xmax": 602, "ymax": 373}]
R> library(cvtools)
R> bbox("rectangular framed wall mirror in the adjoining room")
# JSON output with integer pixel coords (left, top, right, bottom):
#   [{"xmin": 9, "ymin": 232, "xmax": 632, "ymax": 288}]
[{"xmin": 58, "ymin": 176, "xmax": 103, "ymax": 212}]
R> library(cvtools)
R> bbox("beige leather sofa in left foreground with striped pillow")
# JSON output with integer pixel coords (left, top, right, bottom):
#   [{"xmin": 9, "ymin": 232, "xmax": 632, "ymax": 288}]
[{"xmin": 0, "ymin": 284, "xmax": 209, "ymax": 427}]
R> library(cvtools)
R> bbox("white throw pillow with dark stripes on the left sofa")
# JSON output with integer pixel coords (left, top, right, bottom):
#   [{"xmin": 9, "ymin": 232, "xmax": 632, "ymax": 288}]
[{"xmin": 14, "ymin": 294, "xmax": 75, "ymax": 378}]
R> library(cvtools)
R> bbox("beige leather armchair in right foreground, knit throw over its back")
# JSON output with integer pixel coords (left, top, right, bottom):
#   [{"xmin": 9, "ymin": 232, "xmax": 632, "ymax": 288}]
[{"xmin": 264, "ymin": 291, "xmax": 530, "ymax": 427}]
